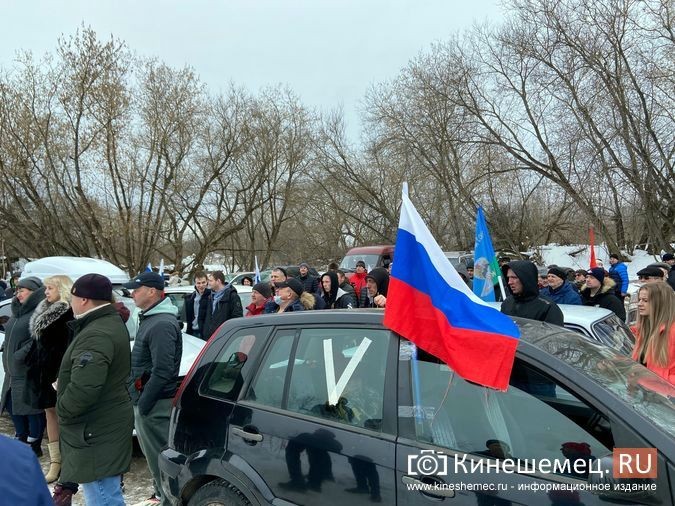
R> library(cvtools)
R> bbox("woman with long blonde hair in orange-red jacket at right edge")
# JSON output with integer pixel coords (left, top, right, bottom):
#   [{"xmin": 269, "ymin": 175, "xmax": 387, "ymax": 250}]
[{"xmin": 633, "ymin": 283, "xmax": 675, "ymax": 385}]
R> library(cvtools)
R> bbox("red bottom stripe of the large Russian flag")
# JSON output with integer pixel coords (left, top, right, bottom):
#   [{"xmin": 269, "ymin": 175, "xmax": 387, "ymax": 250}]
[{"xmin": 384, "ymin": 277, "xmax": 518, "ymax": 391}]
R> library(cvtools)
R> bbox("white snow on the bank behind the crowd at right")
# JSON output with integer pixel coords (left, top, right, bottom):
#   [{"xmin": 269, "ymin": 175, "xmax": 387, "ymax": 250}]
[{"xmin": 534, "ymin": 244, "xmax": 672, "ymax": 280}]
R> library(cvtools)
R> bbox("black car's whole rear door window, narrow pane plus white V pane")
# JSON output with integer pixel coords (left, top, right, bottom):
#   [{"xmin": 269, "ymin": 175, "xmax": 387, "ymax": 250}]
[{"xmin": 246, "ymin": 328, "xmax": 390, "ymax": 432}]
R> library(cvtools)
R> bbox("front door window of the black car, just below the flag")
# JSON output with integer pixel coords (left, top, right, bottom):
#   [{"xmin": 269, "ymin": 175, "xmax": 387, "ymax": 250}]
[{"xmin": 408, "ymin": 343, "xmax": 614, "ymax": 479}]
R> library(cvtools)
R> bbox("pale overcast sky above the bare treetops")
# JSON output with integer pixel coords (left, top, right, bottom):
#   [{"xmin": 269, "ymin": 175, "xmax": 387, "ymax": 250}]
[{"xmin": 0, "ymin": 0, "xmax": 502, "ymax": 140}]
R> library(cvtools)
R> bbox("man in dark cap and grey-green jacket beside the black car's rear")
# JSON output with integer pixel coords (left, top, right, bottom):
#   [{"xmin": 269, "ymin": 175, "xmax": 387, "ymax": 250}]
[{"xmin": 124, "ymin": 272, "xmax": 182, "ymax": 504}]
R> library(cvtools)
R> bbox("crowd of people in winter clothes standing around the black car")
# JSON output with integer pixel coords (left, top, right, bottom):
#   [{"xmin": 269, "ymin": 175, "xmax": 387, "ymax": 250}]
[{"xmin": 0, "ymin": 251, "xmax": 675, "ymax": 505}]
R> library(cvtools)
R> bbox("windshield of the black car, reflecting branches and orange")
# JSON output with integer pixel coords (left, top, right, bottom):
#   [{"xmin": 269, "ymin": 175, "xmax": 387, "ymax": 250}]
[{"xmin": 519, "ymin": 320, "xmax": 675, "ymax": 437}]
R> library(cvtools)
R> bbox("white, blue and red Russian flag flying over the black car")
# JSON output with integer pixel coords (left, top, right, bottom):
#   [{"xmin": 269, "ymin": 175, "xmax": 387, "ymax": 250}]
[{"xmin": 384, "ymin": 191, "xmax": 520, "ymax": 390}]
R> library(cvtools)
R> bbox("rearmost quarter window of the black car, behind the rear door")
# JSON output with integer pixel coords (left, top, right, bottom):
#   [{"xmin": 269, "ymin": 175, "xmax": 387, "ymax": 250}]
[{"xmin": 200, "ymin": 327, "xmax": 267, "ymax": 400}]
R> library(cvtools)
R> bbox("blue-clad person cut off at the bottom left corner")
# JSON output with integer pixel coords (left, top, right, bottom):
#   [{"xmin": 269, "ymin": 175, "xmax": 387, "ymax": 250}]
[{"xmin": 0, "ymin": 435, "xmax": 54, "ymax": 506}]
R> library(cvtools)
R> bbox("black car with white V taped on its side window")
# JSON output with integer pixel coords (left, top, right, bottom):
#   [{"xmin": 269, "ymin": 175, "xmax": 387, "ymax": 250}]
[{"xmin": 159, "ymin": 310, "xmax": 675, "ymax": 506}]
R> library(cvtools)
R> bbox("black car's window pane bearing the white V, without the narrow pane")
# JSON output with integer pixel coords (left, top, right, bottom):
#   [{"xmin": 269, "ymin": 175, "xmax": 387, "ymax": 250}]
[{"xmin": 287, "ymin": 328, "xmax": 390, "ymax": 431}]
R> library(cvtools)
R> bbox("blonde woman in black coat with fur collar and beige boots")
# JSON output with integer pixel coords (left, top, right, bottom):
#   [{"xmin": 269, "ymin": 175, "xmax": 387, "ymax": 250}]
[{"xmin": 24, "ymin": 275, "xmax": 73, "ymax": 483}]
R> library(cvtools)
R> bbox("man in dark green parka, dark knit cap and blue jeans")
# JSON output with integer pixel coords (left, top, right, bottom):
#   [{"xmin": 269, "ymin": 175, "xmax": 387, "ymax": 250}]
[{"xmin": 55, "ymin": 274, "xmax": 133, "ymax": 505}]
